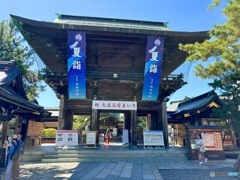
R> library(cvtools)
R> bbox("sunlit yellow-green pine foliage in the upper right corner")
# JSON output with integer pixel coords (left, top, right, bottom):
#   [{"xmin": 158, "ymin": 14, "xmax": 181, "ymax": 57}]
[{"xmin": 179, "ymin": 0, "xmax": 240, "ymax": 78}]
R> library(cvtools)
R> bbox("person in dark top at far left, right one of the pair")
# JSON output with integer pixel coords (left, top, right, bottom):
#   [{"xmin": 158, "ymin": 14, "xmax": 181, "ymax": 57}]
[{"xmin": 12, "ymin": 133, "xmax": 24, "ymax": 180}]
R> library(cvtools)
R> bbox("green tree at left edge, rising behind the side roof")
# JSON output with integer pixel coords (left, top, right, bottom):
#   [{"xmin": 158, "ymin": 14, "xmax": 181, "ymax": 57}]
[{"xmin": 0, "ymin": 20, "xmax": 45, "ymax": 100}]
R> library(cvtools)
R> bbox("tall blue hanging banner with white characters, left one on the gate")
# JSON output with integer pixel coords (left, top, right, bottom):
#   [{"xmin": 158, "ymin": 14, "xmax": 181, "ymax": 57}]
[{"xmin": 68, "ymin": 31, "xmax": 86, "ymax": 99}]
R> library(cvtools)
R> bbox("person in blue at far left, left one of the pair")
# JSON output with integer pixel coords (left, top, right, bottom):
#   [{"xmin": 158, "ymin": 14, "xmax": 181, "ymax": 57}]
[{"xmin": 4, "ymin": 134, "xmax": 17, "ymax": 180}]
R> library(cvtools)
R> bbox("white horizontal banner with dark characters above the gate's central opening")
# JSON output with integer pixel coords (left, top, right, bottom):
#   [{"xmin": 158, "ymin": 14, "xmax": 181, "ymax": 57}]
[{"xmin": 92, "ymin": 100, "xmax": 137, "ymax": 110}]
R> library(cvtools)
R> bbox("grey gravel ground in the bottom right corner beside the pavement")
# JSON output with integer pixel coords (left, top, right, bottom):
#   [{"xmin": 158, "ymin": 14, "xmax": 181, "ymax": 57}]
[{"xmin": 159, "ymin": 168, "xmax": 240, "ymax": 180}]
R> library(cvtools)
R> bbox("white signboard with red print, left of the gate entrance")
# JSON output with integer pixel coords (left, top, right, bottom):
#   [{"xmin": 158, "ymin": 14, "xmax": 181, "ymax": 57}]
[{"xmin": 56, "ymin": 130, "xmax": 78, "ymax": 146}]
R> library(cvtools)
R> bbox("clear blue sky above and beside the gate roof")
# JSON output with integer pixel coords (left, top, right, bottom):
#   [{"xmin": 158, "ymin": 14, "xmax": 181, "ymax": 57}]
[{"xmin": 0, "ymin": 0, "xmax": 225, "ymax": 107}]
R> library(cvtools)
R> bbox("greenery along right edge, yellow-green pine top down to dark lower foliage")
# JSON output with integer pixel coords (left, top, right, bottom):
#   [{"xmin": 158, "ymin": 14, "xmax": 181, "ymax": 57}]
[{"xmin": 179, "ymin": 0, "xmax": 240, "ymax": 172}]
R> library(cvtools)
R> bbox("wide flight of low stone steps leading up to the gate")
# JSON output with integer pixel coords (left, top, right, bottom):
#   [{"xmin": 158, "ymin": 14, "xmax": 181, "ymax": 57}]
[{"xmin": 22, "ymin": 146, "xmax": 188, "ymax": 162}]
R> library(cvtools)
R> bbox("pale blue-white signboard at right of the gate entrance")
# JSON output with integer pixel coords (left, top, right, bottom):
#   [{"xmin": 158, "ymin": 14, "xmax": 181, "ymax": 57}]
[{"xmin": 143, "ymin": 131, "xmax": 164, "ymax": 147}]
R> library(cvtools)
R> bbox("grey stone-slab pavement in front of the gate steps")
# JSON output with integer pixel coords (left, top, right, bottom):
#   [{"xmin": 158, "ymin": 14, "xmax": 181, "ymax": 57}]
[{"xmin": 16, "ymin": 159, "xmax": 236, "ymax": 180}]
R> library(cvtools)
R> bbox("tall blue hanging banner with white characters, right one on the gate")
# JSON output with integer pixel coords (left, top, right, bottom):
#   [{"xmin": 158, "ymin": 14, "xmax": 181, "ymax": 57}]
[{"xmin": 142, "ymin": 37, "xmax": 164, "ymax": 101}]
